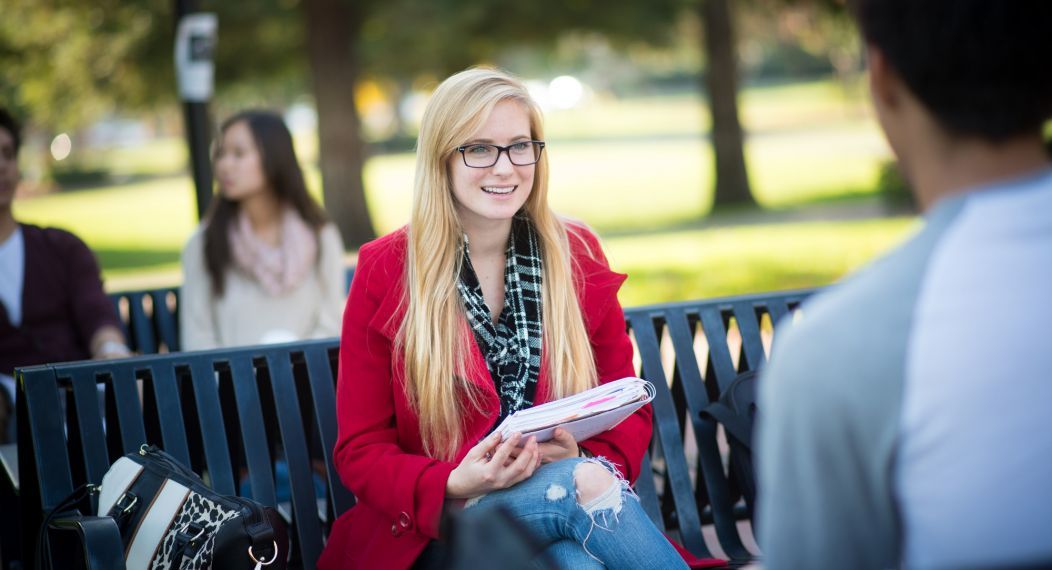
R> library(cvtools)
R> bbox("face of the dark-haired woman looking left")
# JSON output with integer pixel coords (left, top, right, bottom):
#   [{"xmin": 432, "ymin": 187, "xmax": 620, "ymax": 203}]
[{"xmin": 216, "ymin": 121, "xmax": 269, "ymax": 202}]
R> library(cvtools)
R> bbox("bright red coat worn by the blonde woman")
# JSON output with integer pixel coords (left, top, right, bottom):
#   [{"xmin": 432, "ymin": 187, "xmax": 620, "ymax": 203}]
[{"xmin": 318, "ymin": 226, "xmax": 651, "ymax": 569}]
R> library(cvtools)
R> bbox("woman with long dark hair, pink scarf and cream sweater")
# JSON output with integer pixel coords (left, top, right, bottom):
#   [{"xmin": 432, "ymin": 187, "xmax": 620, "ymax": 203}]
[{"xmin": 179, "ymin": 110, "xmax": 346, "ymax": 350}]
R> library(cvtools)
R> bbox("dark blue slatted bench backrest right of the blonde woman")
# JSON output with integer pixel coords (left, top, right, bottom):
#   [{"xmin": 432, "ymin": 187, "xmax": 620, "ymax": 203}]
[{"xmin": 625, "ymin": 290, "xmax": 813, "ymax": 562}]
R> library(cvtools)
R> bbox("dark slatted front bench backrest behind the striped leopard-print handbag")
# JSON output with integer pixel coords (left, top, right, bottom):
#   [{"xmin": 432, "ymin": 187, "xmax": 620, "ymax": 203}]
[{"xmin": 18, "ymin": 339, "xmax": 353, "ymax": 568}]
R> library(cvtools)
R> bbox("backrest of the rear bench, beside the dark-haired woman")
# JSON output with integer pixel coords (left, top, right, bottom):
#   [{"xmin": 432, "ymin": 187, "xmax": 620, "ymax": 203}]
[{"xmin": 109, "ymin": 265, "xmax": 355, "ymax": 354}]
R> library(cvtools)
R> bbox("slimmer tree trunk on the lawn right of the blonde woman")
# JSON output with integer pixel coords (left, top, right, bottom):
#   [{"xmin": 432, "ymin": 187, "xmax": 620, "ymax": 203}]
[{"xmin": 701, "ymin": 0, "xmax": 755, "ymax": 206}]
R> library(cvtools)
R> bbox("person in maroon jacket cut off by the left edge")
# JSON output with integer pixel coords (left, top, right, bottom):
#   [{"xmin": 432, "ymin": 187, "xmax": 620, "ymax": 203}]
[{"xmin": 0, "ymin": 108, "xmax": 128, "ymax": 442}]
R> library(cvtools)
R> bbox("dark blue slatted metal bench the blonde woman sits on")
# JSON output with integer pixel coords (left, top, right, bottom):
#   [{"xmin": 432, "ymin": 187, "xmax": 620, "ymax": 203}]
[{"xmin": 2, "ymin": 291, "xmax": 811, "ymax": 568}]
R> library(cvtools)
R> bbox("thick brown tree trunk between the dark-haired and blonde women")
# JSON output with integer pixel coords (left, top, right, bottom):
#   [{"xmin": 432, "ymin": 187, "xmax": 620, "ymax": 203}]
[{"xmin": 303, "ymin": 0, "xmax": 376, "ymax": 249}]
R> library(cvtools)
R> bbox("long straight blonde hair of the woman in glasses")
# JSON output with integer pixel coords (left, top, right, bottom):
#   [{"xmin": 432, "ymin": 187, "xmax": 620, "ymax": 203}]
[{"xmin": 398, "ymin": 68, "xmax": 596, "ymax": 460}]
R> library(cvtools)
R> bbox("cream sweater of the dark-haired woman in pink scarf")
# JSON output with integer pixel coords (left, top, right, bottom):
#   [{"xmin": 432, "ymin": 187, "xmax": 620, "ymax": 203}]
[{"xmin": 179, "ymin": 223, "xmax": 347, "ymax": 350}]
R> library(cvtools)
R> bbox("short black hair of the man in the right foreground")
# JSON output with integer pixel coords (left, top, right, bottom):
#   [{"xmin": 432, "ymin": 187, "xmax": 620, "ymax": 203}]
[{"xmin": 853, "ymin": 0, "xmax": 1052, "ymax": 142}]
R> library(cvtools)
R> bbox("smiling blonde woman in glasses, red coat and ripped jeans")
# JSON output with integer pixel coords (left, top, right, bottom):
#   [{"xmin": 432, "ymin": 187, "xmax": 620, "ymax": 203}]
[{"xmin": 320, "ymin": 68, "xmax": 685, "ymax": 568}]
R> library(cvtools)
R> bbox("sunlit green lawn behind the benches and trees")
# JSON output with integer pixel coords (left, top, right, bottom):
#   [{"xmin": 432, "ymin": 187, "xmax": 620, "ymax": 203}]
[{"xmin": 15, "ymin": 81, "xmax": 912, "ymax": 304}]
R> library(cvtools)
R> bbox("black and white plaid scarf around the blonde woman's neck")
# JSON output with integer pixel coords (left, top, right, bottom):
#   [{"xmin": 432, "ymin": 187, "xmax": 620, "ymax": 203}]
[{"xmin": 457, "ymin": 215, "xmax": 543, "ymax": 425}]
